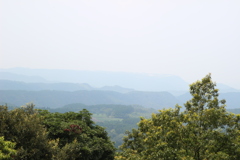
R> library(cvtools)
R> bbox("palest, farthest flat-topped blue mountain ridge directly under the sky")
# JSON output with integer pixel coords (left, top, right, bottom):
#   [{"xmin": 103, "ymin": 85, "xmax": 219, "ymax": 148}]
[{"xmin": 0, "ymin": 68, "xmax": 240, "ymax": 95}]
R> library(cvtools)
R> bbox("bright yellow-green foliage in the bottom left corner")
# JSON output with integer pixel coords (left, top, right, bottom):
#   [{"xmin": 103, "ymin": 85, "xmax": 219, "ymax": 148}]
[{"xmin": 0, "ymin": 137, "xmax": 16, "ymax": 160}]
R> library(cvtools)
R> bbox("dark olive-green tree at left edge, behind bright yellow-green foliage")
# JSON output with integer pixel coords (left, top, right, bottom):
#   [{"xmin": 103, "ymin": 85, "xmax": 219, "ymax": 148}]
[{"xmin": 0, "ymin": 104, "xmax": 52, "ymax": 160}]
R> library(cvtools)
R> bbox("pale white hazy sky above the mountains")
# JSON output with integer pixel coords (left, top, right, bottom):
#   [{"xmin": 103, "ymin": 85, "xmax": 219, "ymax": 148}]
[{"xmin": 0, "ymin": 0, "xmax": 240, "ymax": 89}]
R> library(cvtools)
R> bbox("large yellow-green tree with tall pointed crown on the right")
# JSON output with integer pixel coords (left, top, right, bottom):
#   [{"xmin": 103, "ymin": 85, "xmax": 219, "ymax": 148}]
[{"xmin": 116, "ymin": 74, "xmax": 240, "ymax": 160}]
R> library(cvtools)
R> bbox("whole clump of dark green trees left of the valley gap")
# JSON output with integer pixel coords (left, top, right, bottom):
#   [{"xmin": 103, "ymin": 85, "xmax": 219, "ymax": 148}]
[{"xmin": 0, "ymin": 104, "xmax": 115, "ymax": 160}]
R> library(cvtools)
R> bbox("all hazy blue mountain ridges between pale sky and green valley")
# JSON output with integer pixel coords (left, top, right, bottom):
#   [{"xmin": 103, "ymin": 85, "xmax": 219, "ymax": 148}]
[{"xmin": 0, "ymin": 68, "xmax": 240, "ymax": 109}]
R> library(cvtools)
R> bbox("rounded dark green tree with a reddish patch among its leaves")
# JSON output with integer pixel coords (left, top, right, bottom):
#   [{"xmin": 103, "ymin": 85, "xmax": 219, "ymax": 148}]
[{"xmin": 39, "ymin": 109, "xmax": 115, "ymax": 160}]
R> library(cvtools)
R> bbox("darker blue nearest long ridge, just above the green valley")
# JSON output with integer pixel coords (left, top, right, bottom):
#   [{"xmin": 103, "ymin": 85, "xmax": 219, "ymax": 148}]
[{"xmin": 0, "ymin": 90, "xmax": 180, "ymax": 109}]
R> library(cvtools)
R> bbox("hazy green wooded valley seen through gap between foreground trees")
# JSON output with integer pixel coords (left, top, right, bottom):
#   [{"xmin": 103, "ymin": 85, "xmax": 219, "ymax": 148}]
[{"xmin": 49, "ymin": 103, "xmax": 156, "ymax": 148}]
